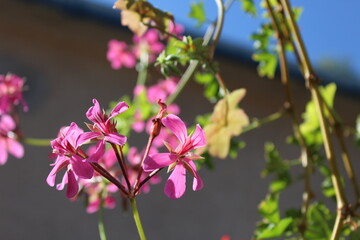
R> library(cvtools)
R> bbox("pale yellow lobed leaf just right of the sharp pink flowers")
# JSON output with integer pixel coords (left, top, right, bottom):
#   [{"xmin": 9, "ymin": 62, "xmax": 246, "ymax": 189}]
[{"xmin": 197, "ymin": 89, "xmax": 249, "ymax": 158}]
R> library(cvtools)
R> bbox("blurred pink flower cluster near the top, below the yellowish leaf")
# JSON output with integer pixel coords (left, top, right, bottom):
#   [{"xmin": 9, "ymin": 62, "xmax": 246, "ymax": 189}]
[{"xmin": 106, "ymin": 24, "xmax": 184, "ymax": 69}]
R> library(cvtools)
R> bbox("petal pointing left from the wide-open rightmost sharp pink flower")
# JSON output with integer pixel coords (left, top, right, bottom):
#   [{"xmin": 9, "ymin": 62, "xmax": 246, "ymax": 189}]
[{"xmin": 143, "ymin": 153, "xmax": 178, "ymax": 172}]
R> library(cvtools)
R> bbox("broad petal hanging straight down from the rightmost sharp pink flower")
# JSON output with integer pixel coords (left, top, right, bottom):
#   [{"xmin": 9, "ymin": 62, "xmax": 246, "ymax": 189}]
[{"xmin": 164, "ymin": 164, "xmax": 186, "ymax": 199}]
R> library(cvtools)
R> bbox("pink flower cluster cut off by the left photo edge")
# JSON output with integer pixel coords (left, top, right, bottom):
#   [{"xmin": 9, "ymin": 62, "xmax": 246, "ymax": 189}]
[{"xmin": 0, "ymin": 74, "xmax": 28, "ymax": 165}]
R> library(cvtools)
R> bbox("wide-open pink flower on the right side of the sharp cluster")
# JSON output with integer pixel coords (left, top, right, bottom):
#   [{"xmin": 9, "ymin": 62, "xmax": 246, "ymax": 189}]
[{"xmin": 143, "ymin": 114, "xmax": 206, "ymax": 199}]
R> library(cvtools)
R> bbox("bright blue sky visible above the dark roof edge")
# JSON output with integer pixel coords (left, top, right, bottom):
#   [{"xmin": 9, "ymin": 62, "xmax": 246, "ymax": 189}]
[{"xmin": 90, "ymin": 0, "xmax": 360, "ymax": 82}]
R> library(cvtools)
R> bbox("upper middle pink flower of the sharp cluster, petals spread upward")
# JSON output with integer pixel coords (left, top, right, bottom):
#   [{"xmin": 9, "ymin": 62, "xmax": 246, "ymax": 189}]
[{"xmin": 78, "ymin": 99, "xmax": 129, "ymax": 161}]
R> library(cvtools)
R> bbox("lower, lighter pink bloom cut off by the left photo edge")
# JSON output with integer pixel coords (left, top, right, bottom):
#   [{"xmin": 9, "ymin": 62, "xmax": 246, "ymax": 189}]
[{"xmin": 0, "ymin": 115, "xmax": 24, "ymax": 165}]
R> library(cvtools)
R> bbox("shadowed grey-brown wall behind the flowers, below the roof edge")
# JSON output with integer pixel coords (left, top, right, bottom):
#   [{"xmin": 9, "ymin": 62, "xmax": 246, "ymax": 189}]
[{"xmin": 0, "ymin": 0, "xmax": 360, "ymax": 240}]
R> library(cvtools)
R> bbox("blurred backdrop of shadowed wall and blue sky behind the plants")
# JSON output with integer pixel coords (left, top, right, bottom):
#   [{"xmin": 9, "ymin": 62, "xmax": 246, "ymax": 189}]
[{"xmin": 0, "ymin": 0, "xmax": 360, "ymax": 240}]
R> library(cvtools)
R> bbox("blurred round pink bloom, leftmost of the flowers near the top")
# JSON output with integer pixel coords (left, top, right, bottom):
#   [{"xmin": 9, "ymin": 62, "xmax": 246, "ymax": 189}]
[{"xmin": 106, "ymin": 39, "xmax": 136, "ymax": 69}]
